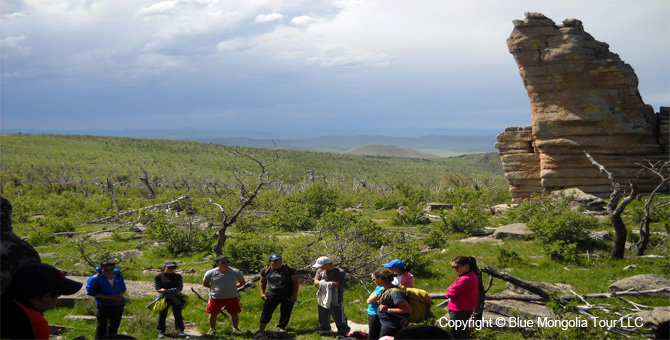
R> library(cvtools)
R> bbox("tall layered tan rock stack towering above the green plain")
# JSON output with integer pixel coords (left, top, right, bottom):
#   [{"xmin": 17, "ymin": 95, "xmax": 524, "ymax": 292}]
[{"xmin": 496, "ymin": 13, "xmax": 668, "ymax": 203}]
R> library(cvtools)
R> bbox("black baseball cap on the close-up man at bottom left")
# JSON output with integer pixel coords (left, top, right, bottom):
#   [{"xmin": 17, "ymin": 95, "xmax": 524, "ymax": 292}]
[{"xmin": 10, "ymin": 263, "xmax": 83, "ymax": 296}]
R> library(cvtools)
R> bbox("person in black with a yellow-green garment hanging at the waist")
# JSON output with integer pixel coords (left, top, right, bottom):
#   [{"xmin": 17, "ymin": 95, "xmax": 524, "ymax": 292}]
[{"xmin": 154, "ymin": 261, "xmax": 186, "ymax": 338}]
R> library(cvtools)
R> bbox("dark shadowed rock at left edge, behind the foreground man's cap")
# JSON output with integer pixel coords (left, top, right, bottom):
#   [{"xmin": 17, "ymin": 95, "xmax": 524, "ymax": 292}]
[{"xmin": 0, "ymin": 196, "xmax": 42, "ymax": 292}]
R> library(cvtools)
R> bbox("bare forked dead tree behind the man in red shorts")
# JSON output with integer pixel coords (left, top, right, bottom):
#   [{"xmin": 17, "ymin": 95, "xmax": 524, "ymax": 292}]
[{"xmin": 209, "ymin": 148, "xmax": 279, "ymax": 256}]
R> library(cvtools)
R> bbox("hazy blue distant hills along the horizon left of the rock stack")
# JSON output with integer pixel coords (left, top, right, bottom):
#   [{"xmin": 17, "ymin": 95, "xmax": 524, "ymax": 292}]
[{"xmin": 1, "ymin": 128, "xmax": 500, "ymax": 158}]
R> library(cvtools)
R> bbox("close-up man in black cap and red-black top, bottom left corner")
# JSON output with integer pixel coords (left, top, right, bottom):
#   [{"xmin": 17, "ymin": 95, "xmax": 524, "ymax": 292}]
[{"xmin": 0, "ymin": 263, "xmax": 82, "ymax": 339}]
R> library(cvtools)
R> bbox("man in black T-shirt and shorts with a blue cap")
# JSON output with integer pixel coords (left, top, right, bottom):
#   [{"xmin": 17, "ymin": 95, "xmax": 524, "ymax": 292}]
[{"xmin": 259, "ymin": 254, "xmax": 300, "ymax": 333}]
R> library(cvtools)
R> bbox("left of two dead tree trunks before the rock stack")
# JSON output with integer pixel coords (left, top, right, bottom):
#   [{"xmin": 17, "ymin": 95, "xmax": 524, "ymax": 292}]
[{"xmin": 584, "ymin": 151, "xmax": 637, "ymax": 260}]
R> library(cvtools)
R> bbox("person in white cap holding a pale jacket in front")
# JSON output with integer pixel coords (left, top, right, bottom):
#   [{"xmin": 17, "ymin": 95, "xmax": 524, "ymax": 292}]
[{"xmin": 312, "ymin": 256, "xmax": 351, "ymax": 337}]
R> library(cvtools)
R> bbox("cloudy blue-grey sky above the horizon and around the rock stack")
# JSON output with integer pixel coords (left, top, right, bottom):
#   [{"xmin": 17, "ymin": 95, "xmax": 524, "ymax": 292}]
[{"xmin": 0, "ymin": 0, "xmax": 670, "ymax": 136}]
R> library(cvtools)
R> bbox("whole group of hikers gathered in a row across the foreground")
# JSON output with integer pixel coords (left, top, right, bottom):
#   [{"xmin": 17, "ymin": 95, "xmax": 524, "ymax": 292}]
[{"xmin": 0, "ymin": 254, "xmax": 483, "ymax": 340}]
